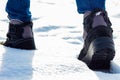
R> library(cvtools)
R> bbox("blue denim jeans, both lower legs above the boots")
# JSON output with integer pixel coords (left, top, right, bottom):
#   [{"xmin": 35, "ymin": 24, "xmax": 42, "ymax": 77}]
[{"xmin": 6, "ymin": 0, "xmax": 105, "ymax": 22}]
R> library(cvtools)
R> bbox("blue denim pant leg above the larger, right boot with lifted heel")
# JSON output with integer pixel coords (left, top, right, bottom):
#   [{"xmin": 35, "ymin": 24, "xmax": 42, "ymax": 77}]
[{"xmin": 76, "ymin": 0, "xmax": 105, "ymax": 13}]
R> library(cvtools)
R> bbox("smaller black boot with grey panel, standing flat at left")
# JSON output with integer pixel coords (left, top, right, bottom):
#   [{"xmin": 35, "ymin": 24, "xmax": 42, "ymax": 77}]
[{"xmin": 4, "ymin": 21, "xmax": 36, "ymax": 50}]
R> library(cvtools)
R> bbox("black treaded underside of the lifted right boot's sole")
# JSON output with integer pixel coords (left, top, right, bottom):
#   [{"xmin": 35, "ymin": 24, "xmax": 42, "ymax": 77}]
[{"xmin": 88, "ymin": 49, "xmax": 114, "ymax": 70}]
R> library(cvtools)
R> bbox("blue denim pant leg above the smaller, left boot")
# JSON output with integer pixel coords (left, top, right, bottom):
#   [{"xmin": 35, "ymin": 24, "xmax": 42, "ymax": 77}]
[{"xmin": 6, "ymin": 0, "xmax": 31, "ymax": 22}]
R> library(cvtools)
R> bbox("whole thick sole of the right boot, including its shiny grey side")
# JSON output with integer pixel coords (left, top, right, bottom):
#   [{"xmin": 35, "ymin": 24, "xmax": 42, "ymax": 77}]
[{"xmin": 82, "ymin": 37, "xmax": 115, "ymax": 70}]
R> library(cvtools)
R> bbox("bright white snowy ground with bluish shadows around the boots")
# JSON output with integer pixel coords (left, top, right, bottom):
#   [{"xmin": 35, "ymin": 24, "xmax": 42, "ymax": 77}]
[{"xmin": 0, "ymin": 0, "xmax": 120, "ymax": 80}]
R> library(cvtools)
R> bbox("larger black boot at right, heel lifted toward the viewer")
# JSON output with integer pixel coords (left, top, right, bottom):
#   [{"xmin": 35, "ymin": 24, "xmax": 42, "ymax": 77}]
[{"xmin": 78, "ymin": 9, "xmax": 115, "ymax": 69}]
